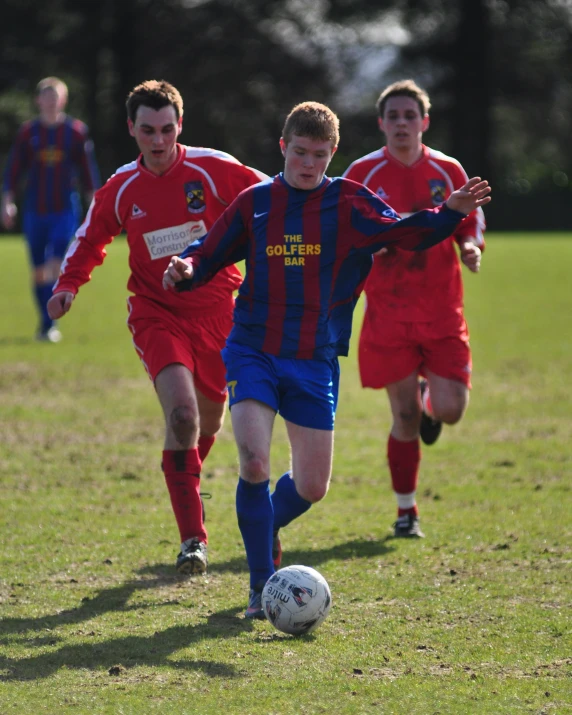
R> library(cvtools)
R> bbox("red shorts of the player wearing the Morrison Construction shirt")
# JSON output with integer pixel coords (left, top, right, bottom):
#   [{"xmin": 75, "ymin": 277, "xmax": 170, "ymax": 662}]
[{"xmin": 127, "ymin": 296, "xmax": 234, "ymax": 403}]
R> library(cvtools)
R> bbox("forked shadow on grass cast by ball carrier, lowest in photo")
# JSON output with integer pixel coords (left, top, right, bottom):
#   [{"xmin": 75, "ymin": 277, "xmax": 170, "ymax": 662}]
[{"xmin": 0, "ymin": 608, "xmax": 253, "ymax": 682}]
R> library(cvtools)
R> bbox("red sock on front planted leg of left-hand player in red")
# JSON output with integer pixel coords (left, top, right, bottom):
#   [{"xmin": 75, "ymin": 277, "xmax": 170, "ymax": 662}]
[{"xmin": 161, "ymin": 448, "xmax": 207, "ymax": 544}]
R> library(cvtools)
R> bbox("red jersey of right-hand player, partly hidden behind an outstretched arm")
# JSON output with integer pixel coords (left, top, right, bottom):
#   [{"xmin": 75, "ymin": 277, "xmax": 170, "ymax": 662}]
[{"xmin": 344, "ymin": 145, "xmax": 485, "ymax": 322}]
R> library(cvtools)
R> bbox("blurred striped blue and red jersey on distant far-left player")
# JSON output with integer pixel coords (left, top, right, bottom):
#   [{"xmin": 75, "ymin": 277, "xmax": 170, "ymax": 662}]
[{"xmin": 3, "ymin": 115, "xmax": 100, "ymax": 215}]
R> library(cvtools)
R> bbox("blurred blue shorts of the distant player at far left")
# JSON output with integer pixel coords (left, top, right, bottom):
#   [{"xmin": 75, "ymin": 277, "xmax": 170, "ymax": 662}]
[{"xmin": 22, "ymin": 210, "xmax": 79, "ymax": 267}]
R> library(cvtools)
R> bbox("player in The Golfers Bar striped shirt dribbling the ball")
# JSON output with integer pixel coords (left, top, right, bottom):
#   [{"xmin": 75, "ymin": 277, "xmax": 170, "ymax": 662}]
[{"xmin": 163, "ymin": 102, "xmax": 490, "ymax": 618}]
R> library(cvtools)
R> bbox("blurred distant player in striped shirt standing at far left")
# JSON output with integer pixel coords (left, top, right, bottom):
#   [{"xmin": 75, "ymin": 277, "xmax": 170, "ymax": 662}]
[{"xmin": 1, "ymin": 77, "xmax": 100, "ymax": 343}]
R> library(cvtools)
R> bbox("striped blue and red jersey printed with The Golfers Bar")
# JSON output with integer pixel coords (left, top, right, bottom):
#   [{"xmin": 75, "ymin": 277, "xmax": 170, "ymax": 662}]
[{"xmin": 178, "ymin": 174, "xmax": 464, "ymax": 360}]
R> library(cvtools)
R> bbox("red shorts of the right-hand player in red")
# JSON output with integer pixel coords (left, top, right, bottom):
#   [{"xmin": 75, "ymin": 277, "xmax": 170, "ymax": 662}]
[{"xmin": 358, "ymin": 309, "xmax": 472, "ymax": 389}]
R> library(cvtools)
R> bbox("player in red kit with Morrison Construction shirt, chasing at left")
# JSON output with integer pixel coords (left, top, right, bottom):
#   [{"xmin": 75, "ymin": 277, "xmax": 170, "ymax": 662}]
[{"xmin": 48, "ymin": 80, "xmax": 266, "ymax": 574}]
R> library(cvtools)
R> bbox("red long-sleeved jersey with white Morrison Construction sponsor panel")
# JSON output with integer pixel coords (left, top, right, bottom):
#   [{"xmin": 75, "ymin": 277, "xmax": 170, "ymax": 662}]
[{"xmin": 54, "ymin": 144, "xmax": 267, "ymax": 313}]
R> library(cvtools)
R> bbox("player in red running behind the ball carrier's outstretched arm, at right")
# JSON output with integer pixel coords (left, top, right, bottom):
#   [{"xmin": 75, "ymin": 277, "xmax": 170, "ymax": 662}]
[{"xmin": 344, "ymin": 80, "xmax": 485, "ymax": 537}]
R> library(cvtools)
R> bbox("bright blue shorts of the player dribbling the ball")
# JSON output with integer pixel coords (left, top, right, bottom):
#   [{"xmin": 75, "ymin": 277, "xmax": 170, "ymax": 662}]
[{"xmin": 222, "ymin": 343, "xmax": 340, "ymax": 431}]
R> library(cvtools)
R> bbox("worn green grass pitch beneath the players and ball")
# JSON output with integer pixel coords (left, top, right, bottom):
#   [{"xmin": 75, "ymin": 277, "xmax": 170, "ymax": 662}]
[{"xmin": 0, "ymin": 235, "xmax": 572, "ymax": 715}]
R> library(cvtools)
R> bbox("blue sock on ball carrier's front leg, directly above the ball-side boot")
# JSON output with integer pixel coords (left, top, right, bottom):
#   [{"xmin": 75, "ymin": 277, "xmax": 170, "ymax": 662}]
[{"xmin": 236, "ymin": 477, "xmax": 274, "ymax": 588}]
